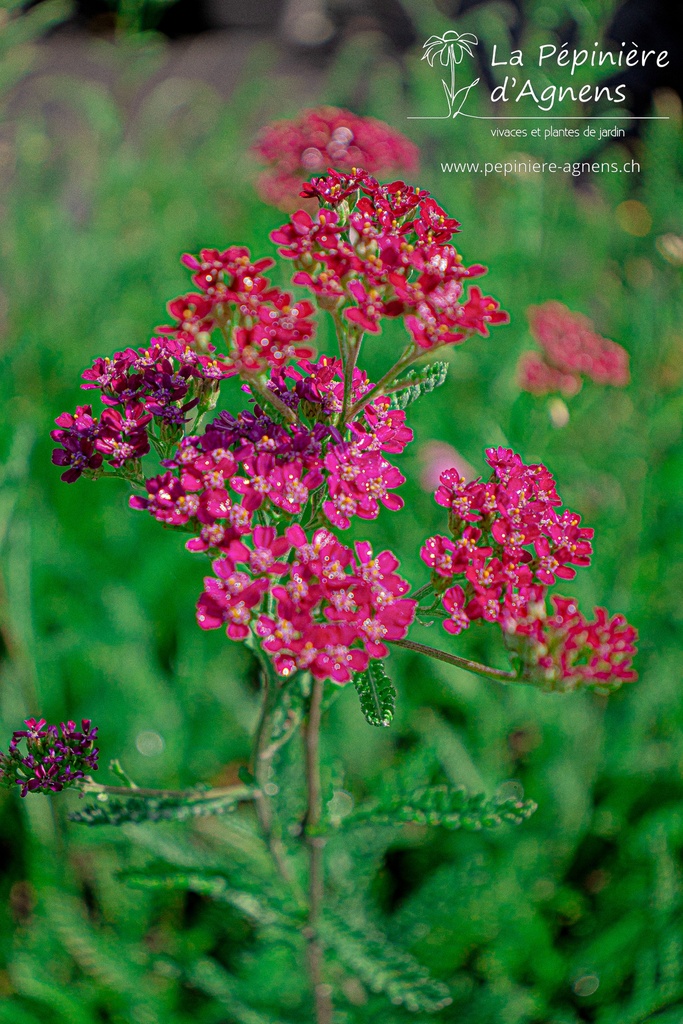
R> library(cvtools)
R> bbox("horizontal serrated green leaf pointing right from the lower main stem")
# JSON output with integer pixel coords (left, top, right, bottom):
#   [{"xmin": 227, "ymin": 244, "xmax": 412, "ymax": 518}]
[{"xmin": 343, "ymin": 785, "xmax": 537, "ymax": 831}]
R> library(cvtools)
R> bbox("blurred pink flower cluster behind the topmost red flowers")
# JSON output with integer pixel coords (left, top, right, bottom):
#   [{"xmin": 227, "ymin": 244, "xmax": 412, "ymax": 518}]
[{"xmin": 253, "ymin": 106, "xmax": 419, "ymax": 210}]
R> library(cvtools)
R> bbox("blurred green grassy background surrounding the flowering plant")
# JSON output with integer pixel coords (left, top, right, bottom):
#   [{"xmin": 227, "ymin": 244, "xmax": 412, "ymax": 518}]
[{"xmin": 0, "ymin": 0, "xmax": 683, "ymax": 1024}]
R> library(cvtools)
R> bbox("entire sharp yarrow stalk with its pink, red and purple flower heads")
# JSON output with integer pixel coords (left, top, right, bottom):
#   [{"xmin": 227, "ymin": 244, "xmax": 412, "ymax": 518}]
[{"xmin": 0, "ymin": 163, "xmax": 636, "ymax": 1024}]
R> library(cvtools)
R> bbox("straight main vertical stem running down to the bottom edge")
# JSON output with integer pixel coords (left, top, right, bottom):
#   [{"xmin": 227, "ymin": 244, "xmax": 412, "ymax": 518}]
[{"xmin": 304, "ymin": 679, "xmax": 333, "ymax": 1024}]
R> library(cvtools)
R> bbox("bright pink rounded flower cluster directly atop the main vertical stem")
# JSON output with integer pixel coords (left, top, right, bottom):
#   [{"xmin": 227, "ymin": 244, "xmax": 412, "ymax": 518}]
[{"xmin": 198, "ymin": 524, "xmax": 416, "ymax": 683}]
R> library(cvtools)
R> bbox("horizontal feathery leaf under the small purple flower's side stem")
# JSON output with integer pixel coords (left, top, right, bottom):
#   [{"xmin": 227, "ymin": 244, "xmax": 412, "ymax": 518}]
[{"xmin": 69, "ymin": 790, "xmax": 250, "ymax": 825}]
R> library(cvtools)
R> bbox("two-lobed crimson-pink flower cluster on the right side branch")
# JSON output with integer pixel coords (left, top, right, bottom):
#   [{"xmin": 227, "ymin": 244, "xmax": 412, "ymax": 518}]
[{"xmin": 421, "ymin": 447, "xmax": 636, "ymax": 687}]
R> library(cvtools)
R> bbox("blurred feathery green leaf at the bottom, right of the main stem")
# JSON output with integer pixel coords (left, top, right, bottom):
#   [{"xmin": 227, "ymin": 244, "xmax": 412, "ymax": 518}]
[{"xmin": 321, "ymin": 913, "xmax": 453, "ymax": 1014}]
